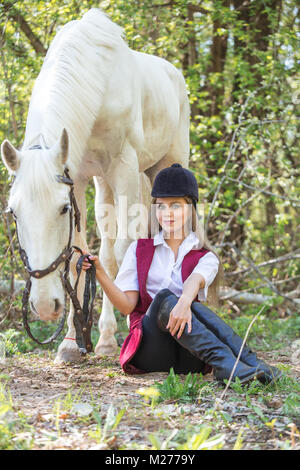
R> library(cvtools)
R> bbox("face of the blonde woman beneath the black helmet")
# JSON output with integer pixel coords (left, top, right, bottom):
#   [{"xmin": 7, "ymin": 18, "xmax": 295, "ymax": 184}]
[{"xmin": 156, "ymin": 197, "xmax": 192, "ymax": 239}]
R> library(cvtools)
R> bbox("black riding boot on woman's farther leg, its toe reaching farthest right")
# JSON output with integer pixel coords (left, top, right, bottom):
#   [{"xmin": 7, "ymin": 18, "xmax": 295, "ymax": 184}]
[{"xmin": 191, "ymin": 302, "xmax": 282, "ymax": 384}]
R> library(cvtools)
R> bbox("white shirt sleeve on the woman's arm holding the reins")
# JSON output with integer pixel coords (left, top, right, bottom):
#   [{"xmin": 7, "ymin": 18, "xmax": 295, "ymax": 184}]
[{"xmin": 114, "ymin": 240, "xmax": 139, "ymax": 292}]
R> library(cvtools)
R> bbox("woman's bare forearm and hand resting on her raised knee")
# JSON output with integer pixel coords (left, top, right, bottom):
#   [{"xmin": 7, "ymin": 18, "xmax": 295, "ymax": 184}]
[{"xmin": 167, "ymin": 273, "xmax": 205, "ymax": 338}]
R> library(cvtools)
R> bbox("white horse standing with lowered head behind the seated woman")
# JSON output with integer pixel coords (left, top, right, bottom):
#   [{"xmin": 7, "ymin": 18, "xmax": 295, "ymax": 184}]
[{"xmin": 1, "ymin": 9, "xmax": 189, "ymax": 362}]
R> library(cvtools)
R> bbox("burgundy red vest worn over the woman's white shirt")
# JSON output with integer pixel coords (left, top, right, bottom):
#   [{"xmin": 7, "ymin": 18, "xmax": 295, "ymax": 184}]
[{"xmin": 120, "ymin": 238, "xmax": 209, "ymax": 374}]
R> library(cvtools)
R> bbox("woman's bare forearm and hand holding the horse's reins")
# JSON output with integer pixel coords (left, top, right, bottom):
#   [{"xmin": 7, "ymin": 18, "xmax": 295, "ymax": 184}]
[{"xmin": 82, "ymin": 252, "xmax": 139, "ymax": 315}]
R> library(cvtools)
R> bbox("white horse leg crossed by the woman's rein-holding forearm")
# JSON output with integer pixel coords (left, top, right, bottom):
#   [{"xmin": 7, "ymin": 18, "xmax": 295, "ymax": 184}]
[{"xmin": 94, "ymin": 177, "xmax": 118, "ymax": 356}]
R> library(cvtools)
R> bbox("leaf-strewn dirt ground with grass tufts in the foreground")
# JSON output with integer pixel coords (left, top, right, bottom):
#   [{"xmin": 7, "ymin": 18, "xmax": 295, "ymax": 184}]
[{"xmin": 0, "ymin": 349, "xmax": 300, "ymax": 450}]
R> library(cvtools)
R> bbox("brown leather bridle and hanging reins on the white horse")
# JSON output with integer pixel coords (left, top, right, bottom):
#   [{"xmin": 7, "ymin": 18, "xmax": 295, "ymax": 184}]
[{"xmin": 7, "ymin": 158, "xmax": 96, "ymax": 354}]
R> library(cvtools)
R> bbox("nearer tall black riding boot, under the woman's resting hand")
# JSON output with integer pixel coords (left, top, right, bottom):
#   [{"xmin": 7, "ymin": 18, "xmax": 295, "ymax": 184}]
[{"xmin": 149, "ymin": 289, "xmax": 264, "ymax": 383}]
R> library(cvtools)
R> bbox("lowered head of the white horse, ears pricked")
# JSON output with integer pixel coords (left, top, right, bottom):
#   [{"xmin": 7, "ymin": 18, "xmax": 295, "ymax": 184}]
[{"xmin": 1, "ymin": 130, "xmax": 71, "ymax": 321}]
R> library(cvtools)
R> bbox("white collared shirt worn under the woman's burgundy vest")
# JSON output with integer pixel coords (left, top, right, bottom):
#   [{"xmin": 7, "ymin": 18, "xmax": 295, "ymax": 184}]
[{"xmin": 114, "ymin": 231, "xmax": 219, "ymax": 302}]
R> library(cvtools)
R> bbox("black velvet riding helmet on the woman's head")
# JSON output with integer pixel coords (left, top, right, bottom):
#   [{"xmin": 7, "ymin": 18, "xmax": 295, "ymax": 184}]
[{"xmin": 151, "ymin": 163, "xmax": 199, "ymax": 207}]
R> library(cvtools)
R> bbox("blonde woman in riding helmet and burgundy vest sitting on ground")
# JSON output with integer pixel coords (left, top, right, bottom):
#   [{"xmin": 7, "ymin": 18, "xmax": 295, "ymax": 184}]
[{"xmin": 83, "ymin": 163, "xmax": 281, "ymax": 383}]
